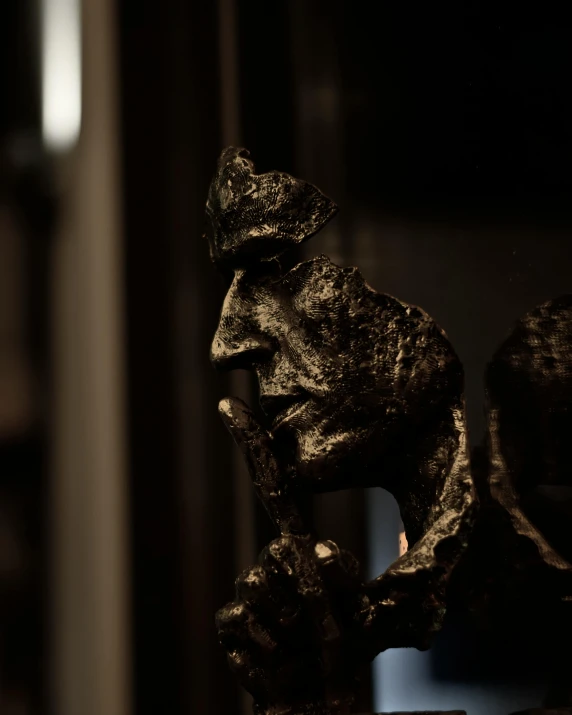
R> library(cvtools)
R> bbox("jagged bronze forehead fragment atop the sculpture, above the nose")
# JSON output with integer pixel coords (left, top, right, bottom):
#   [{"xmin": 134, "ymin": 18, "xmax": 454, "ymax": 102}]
[{"xmin": 207, "ymin": 147, "xmax": 338, "ymax": 265}]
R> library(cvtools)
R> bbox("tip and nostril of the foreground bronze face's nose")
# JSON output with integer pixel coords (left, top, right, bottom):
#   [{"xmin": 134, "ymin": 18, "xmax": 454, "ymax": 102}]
[{"xmin": 211, "ymin": 324, "xmax": 275, "ymax": 370}]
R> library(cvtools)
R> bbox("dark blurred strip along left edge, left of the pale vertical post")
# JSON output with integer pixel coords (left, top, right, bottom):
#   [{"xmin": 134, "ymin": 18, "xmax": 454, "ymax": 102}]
[{"xmin": 0, "ymin": 0, "xmax": 51, "ymax": 715}]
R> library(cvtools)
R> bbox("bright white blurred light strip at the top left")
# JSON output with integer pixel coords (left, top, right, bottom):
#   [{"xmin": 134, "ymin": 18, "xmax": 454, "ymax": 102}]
[{"xmin": 40, "ymin": 0, "xmax": 82, "ymax": 153}]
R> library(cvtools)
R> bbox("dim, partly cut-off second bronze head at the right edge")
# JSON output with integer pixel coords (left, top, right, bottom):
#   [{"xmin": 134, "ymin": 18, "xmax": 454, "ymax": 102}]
[{"xmin": 487, "ymin": 296, "xmax": 572, "ymax": 573}]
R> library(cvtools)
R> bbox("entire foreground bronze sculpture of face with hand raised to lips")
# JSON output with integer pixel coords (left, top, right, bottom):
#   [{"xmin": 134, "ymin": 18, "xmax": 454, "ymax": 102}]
[{"xmin": 207, "ymin": 148, "xmax": 473, "ymax": 712}]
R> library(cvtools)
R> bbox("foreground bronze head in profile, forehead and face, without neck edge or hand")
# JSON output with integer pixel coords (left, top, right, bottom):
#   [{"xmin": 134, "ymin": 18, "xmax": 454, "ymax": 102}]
[{"xmin": 207, "ymin": 149, "xmax": 463, "ymax": 520}]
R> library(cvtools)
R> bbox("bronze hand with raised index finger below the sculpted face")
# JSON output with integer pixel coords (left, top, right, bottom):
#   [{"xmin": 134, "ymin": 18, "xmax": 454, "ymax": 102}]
[{"xmin": 217, "ymin": 399, "xmax": 370, "ymax": 715}]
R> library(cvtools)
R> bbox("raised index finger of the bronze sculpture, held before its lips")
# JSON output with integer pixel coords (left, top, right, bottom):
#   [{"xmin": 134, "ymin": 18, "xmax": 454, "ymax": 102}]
[{"xmin": 219, "ymin": 397, "xmax": 306, "ymax": 534}]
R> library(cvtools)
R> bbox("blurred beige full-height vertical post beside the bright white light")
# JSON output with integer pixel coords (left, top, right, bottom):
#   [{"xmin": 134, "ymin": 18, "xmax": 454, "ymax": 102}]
[{"xmin": 49, "ymin": 0, "xmax": 132, "ymax": 715}]
